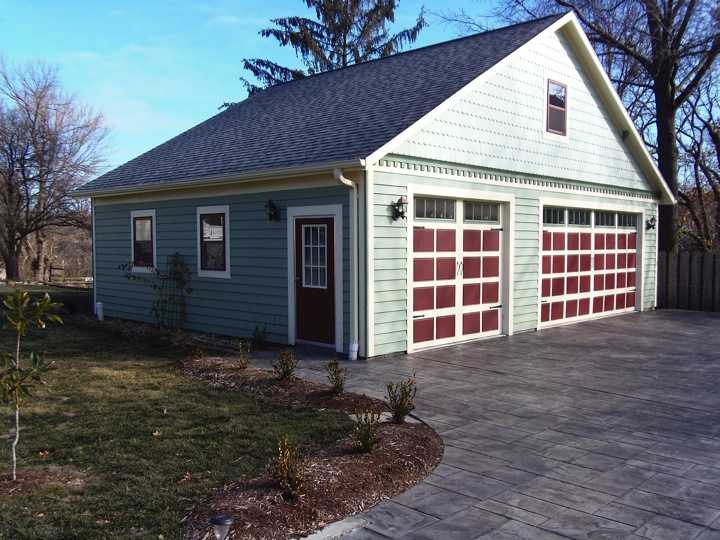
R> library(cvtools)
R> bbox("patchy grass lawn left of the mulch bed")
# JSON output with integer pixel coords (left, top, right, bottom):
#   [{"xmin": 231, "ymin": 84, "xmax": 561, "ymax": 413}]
[{"xmin": 0, "ymin": 318, "xmax": 351, "ymax": 539}]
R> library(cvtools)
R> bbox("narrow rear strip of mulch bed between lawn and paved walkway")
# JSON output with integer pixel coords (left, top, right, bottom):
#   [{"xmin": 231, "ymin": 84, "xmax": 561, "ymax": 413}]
[{"xmin": 182, "ymin": 357, "xmax": 387, "ymax": 414}]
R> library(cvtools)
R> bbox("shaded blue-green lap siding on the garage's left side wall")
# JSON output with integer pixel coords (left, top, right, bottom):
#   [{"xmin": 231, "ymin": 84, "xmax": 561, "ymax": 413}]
[{"xmin": 95, "ymin": 186, "xmax": 350, "ymax": 349}]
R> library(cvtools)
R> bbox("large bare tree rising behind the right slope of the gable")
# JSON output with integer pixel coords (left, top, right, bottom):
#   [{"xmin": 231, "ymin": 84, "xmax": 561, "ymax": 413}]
[{"xmin": 442, "ymin": 0, "xmax": 720, "ymax": 250}]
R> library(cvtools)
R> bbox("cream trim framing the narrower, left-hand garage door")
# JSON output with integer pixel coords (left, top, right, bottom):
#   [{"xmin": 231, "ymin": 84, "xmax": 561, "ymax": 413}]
[{"xmin": 406, "ymin": 184, "xmax": 515, "ymax": 353}]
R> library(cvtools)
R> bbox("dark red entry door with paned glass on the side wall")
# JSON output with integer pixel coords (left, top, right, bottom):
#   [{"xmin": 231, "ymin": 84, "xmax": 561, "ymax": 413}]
[{"xmin": 295, "ymin": 218, "xmax": 335, "ymax": 344}]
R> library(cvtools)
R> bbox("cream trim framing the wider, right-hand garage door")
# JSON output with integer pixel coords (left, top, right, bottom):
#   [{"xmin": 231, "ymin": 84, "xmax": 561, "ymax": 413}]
[{"xmin": 536, "ymin": 197, "xmax": 646, "ymax": 331}]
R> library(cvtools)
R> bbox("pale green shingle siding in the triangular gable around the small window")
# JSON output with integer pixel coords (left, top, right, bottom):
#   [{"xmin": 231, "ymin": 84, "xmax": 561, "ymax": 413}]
[{"xmin": 394, "ymin": 28, "xmax": 649, "ymax": 194}]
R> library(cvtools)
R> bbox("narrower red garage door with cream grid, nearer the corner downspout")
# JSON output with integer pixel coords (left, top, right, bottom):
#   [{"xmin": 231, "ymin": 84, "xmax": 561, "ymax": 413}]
[{"xmin": 411, "ymin": 197, "xmax": 502, "ymax": 348}]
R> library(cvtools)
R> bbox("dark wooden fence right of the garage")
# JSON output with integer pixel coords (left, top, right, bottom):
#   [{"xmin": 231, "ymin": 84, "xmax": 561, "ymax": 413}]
[{"xmin": 658, "ymin": 251, "xmax": 720, "ymax": 311}]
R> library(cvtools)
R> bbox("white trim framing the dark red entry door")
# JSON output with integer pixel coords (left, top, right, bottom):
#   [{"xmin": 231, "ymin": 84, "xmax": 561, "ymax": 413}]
[{"xmin": 287, "ymin": 204, "xmax": 343, "ymax": 352}]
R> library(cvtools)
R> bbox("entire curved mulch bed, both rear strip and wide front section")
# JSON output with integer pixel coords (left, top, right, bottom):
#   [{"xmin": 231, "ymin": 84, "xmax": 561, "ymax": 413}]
[{"xmin": 182, "ymin": 358, "xmax": 443, "ymax": 539}]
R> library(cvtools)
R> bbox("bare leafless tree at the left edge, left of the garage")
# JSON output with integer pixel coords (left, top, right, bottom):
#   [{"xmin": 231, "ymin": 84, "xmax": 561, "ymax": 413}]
[{"xmin": 0, "ymin": 63, "xmax": 107, "ymax": 280}]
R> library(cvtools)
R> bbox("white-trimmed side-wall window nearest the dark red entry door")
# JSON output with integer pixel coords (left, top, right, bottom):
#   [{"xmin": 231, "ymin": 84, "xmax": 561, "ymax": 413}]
[{"xmin": 197, "ymin": 205, "xmax": 230, "ymax": 278}]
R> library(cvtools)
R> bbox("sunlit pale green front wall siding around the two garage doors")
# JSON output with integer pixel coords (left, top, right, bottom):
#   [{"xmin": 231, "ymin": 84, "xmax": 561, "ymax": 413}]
[{"xmin": 371, "ymin": 157, "xmax": 657, "ymax": 355}]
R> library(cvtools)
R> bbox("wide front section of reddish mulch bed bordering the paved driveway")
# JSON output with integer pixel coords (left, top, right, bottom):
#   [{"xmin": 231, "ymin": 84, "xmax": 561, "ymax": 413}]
[{"xmin": 186, "ymin": 424, "xmax": 442, "ymax": 539}]
